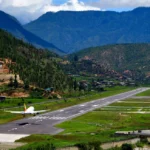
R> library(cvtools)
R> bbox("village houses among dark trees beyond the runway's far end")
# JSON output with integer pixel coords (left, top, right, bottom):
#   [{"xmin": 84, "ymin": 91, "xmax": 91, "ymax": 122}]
[{"xmin": 68, "ymin": 70, "xmax": 136, "ymax": 91}]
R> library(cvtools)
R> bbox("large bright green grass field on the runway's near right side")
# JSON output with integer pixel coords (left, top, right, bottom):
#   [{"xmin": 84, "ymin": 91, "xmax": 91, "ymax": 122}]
[{"xmin": 16, "ymin": 95, "xmax": 150, "ymax": 147}]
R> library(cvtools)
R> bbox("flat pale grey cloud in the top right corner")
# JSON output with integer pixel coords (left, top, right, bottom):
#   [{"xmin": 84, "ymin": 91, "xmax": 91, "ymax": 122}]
[{"xmin": 91, "ymin": 0, "xmax": 150, "ymax": 9}]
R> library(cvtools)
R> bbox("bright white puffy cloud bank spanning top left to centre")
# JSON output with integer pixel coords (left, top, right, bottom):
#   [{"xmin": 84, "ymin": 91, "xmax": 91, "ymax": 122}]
[{"xmin": 0, "ymin": 0, "xmax": 100, "ymax": 23}]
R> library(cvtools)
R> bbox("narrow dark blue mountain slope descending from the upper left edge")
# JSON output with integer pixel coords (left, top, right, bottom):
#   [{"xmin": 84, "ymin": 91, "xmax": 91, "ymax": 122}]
[{"xmin": 0, "ymin": 11, "xmax": 62, "ymax": 53}]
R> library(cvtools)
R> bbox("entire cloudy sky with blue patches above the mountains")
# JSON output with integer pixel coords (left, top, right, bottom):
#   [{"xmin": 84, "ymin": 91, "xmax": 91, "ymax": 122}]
[{"xmin": 0, "ymin": 0, "xmax": 150, "ymax": 23}]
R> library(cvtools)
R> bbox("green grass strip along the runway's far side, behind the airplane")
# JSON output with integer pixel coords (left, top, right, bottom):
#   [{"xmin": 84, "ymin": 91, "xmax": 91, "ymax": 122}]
[{"xmin": 0, "ymin": 87, "xmax": 135, "ymax": 124}]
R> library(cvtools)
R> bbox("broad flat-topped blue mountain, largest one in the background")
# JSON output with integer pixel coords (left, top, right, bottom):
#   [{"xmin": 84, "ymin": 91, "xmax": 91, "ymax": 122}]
[{"xmin": 24, "ymin": 7, "xmax": 150, "ymax": 53}]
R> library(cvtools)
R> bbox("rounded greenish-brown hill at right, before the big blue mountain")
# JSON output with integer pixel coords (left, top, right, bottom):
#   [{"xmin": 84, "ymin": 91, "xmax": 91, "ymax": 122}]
[{"xmin": 69, "ymin": 43, "xmax": 150, "ymax": 73}]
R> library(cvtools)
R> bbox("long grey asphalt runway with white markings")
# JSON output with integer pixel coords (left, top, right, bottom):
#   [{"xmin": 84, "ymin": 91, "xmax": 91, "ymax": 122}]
[{"xmin": 0, "ymin": 88, "xmax": 148, "ymax": 134}]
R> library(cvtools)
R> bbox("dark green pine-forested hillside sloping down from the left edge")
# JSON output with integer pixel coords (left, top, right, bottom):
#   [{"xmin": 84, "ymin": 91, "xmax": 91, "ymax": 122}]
[{"xmin": 0, "ymin": 30, "xmax": 68, "ymax": 90}]
